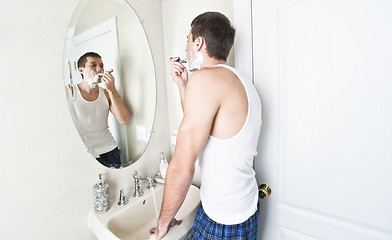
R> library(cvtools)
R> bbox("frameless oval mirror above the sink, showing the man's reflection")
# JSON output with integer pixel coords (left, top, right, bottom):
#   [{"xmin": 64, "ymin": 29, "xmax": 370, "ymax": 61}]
[{"xmin": 64, "ymin": 0, "xmax": 156, "ymax": 168}]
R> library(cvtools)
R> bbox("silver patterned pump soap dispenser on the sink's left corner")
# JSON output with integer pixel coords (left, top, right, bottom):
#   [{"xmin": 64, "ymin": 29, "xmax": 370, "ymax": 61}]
[{"xmin": 93, "ymin": 173, "xmax": 109, "ymax": 214}]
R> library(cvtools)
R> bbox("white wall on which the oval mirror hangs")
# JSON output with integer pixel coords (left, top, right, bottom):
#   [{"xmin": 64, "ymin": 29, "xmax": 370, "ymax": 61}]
[{"xmin": 0, "ymin": 0, "xmax": 169, "ymax": 240}]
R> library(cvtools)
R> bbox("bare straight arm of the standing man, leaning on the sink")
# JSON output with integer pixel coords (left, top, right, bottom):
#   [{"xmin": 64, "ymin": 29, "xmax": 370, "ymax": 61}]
[{"xmin": 154, "ymin": 70, "xmax": 220, "ymax": 239}]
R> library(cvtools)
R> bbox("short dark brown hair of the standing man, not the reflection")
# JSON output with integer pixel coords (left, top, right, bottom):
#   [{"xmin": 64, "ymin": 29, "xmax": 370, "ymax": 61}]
[{"xmin": 191, "ymin": 12, "xmax": 235, "ymax": 61}]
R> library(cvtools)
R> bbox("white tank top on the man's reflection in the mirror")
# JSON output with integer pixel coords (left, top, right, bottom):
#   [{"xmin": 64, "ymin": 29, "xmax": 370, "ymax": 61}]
[{"xmin": 73, "ymin": 85, "xmax": 117, "ymax": 157}]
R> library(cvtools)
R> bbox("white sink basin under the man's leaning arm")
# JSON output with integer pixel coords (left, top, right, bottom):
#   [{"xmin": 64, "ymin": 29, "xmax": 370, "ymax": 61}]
[{"xmin": 88, "ymin": 184, "xmax": 200, "ymax": 240}]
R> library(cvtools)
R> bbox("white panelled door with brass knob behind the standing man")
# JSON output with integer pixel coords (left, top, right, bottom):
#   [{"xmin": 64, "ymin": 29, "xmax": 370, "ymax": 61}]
[{"xmin": 236, "ymin": 0, "xmax": 392, "ymax": 240}]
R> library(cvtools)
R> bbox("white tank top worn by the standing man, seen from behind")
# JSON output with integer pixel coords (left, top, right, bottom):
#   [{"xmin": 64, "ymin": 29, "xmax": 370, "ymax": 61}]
[{"xmin": 199, "ymin": 64, "xmax": 262, "ymax": 225}]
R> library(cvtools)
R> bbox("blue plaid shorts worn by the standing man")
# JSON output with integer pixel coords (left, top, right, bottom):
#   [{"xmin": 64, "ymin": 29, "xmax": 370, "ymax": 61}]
[{"xmin": 190, "ymin": 204, "xmax": 259, "ymax": 240}]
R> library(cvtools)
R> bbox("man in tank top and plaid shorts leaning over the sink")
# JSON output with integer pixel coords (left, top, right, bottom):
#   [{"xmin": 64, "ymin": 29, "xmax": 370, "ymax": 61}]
[{"xmin": 150, "ymin": 12, "xmax": 261, "ymax": 240}]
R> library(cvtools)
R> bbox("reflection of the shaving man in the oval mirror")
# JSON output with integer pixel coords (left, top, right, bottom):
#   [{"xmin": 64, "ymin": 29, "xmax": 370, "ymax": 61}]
[{"xmin": 69, "ymin": 52, "xmax": 129, "ymax": 168}]
